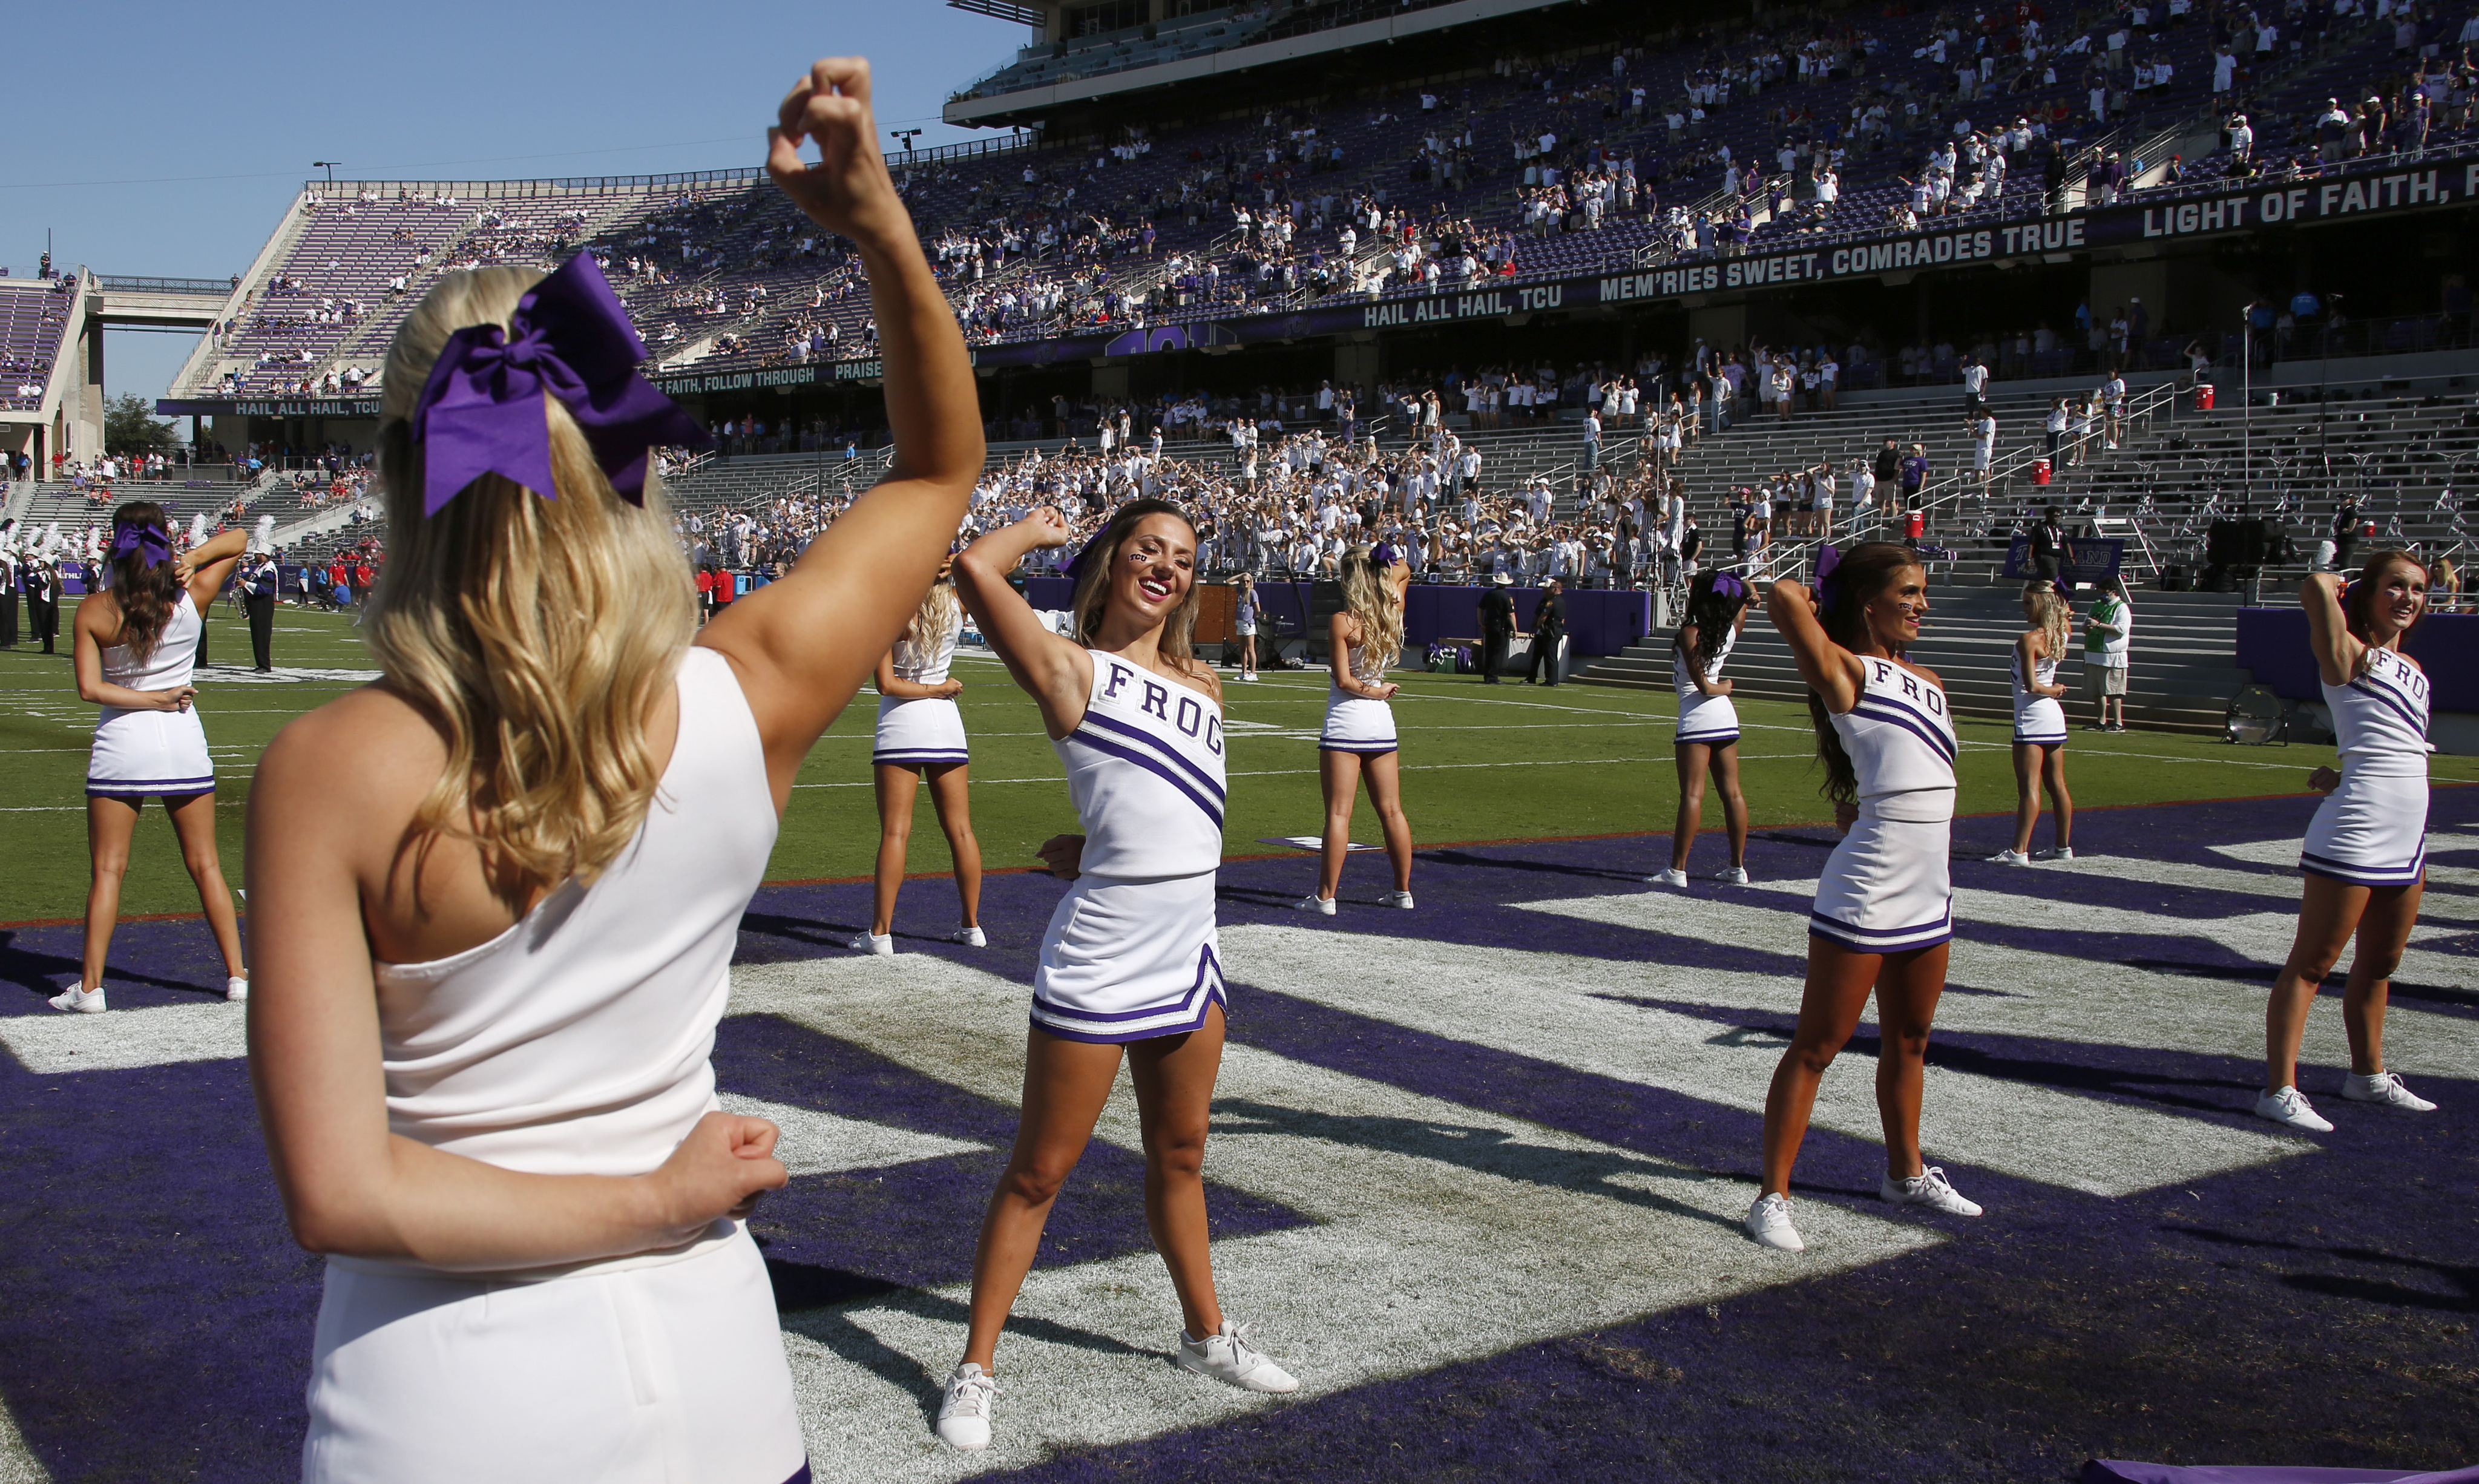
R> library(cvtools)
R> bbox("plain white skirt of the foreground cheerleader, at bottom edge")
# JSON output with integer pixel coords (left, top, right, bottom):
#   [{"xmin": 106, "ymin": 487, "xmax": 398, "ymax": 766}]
[{"xmin": 303, "ymin": 1226, "xmax": 808, "ymax": 1484}]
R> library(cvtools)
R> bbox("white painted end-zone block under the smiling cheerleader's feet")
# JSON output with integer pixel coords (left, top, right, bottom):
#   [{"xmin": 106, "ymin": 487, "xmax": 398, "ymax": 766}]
[{"xmin": 731, "ymin": 954, "xmax": 1941, "ymax": 1482}]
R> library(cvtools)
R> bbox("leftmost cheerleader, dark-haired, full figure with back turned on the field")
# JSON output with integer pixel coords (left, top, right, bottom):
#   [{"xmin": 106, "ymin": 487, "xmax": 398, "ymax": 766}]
[{"xmin": 52, "ymin": 501, "xmax": 251, "ymax": 1013}]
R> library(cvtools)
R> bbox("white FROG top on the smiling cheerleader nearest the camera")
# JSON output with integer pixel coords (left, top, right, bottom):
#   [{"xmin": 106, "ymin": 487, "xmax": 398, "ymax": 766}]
[{"xmin": 1051, "ymin": 649, "xmax": 1224, "ymax": 882}]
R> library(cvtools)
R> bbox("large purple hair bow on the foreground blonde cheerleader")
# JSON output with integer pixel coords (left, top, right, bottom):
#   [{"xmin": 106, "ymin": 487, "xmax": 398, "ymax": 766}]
[{"xmin": 414, "ymin": 253, "xmax": 709, "ymax": 515}]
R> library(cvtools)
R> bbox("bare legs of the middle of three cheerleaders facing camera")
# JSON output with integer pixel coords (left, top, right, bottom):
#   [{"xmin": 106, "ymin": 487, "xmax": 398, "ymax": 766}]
[{"xmin": 1760, "ymin": 936, "xmax": 1954, "ymax": 1197}]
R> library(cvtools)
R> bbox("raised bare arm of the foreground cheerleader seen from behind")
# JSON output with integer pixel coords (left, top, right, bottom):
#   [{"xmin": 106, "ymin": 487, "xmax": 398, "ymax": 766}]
[{"xmin": 697, "ymin": 57, "xmax": 984, "ymax": 810}]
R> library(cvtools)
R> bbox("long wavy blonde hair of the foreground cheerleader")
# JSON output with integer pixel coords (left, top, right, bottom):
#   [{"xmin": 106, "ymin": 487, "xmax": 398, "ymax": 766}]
[{"xmin": 364, "ymin": 268, "xmax": 697, "ymax": 902}]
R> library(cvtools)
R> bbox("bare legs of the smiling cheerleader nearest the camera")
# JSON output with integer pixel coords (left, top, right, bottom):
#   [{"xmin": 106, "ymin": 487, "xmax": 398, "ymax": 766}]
[{"xmin": 964, "ymin": 1006, "xmax": 1222, "ymax": 1373}]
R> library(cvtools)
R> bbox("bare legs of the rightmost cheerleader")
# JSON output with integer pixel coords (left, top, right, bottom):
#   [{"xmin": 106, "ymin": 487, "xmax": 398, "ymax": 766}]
[{"xmin": 2264, "ymin": 875, "xmax": 2427, "ymax": 1090}]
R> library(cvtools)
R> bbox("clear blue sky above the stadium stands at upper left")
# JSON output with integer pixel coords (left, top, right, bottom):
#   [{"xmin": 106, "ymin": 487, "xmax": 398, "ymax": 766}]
[{"xmin": 0, "ymin": 0, "xmax": 1029, "ymax": 416}]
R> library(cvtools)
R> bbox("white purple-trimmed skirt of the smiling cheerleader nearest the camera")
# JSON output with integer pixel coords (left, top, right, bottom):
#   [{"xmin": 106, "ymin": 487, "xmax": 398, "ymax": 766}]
[{"xmin": 1034, "ymin": 872, "xmax": 1230, "ymax": 1043}]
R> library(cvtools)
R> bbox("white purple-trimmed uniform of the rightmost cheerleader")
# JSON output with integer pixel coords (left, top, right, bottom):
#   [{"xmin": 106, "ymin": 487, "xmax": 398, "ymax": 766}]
[{"xmin": 2298, "ymin": 649, "xmax": 2429, "ymax": 887}]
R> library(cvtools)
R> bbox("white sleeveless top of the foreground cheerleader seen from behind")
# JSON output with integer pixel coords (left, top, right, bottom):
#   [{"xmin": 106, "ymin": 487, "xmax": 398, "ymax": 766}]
[{"xmin": 374, "ymin": 649, "xmax": 776, "ymax": 1209}]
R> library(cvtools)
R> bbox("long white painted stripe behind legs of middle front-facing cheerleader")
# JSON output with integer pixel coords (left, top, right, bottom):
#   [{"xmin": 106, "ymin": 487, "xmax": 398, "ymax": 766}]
[{"xmin": 1222, "ymin": 921, "xmax": 2308, "ymax": 1197}]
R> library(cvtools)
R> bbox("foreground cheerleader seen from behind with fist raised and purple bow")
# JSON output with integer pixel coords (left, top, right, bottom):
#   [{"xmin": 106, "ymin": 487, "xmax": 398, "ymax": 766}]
[{"xmin": 251, "ymin": 57, "xmax": 984, "ymax": 1484}]
